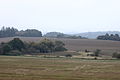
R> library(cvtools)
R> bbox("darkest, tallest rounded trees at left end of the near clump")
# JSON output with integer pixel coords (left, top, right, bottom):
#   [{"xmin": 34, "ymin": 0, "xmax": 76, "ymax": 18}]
[{"xmin": 0, "ymin": 38, "xmax": 25, "ymax": 55}]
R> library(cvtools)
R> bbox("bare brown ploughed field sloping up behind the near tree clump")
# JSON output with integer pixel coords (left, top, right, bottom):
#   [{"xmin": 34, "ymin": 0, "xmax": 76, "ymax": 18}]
[{"xmin": 0, "ymin": 37, "xmax": 120, "ymax": 54}]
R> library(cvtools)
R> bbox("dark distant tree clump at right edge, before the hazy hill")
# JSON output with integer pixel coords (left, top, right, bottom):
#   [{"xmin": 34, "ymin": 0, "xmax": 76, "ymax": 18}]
[{"xmin": 97, "ymin": 34, "xmax": 120, "ymax": 41}]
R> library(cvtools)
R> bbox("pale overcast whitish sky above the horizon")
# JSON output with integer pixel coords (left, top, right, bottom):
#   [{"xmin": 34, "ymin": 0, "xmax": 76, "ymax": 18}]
[{"xmin": 0, "ymin": 0, "xmax": 120, "ymax": 33}]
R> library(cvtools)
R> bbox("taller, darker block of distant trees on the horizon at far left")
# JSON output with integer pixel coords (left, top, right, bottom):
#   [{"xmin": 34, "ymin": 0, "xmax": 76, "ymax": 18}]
[{"xmin": 0, "ymin": 27, "xmax": 42, "ymax": 38}]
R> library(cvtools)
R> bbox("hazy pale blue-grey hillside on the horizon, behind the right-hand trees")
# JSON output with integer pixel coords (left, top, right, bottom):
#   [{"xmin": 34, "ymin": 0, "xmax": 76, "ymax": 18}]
[{"xmin": 76, "ymin": 31, "xmax": 120, "ymax": 39}]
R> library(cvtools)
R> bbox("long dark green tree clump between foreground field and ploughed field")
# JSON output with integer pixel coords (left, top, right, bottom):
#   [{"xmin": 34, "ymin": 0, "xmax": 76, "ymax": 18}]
[{"xmin": 0, "ymin": 38, "xmax": 67, "ymax": 55}]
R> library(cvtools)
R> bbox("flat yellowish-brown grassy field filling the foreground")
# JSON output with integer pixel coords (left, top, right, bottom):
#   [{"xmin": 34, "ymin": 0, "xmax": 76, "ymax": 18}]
[{"xmin": 0, "ymin": 56, "xmax": 120, "ymax": 80}]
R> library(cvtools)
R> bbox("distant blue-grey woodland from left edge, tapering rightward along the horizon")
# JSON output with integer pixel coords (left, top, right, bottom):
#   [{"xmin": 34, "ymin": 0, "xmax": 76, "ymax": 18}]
[{"xmin": 0, "ymin": 27, "xmax": 86, "ymax": 39}]
